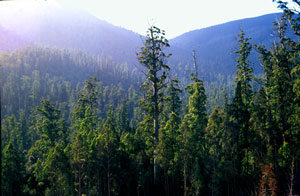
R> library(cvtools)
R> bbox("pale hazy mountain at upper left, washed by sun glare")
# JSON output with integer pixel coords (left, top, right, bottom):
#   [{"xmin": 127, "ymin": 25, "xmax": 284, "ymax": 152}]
[{"xmin": 0, "ymin": 5, "xmax": 142, "ymax": 67}]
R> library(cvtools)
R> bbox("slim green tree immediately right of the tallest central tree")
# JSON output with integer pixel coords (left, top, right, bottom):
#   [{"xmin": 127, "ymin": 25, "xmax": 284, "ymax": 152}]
[{"xmin": 158, "ymin": 79, "xmax": 182, "ymax": 195}]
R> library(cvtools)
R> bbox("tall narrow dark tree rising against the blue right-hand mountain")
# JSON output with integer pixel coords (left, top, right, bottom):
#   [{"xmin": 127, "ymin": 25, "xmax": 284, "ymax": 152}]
[{"xmin": 230, "ymin": 30, "xmax": 254, "ymax": 194}]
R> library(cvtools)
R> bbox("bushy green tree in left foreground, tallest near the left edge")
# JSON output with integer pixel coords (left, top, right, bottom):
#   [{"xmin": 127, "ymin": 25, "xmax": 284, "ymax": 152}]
[{"xmin": 27, "ymin": 100, "xmax": 68, "ymax": 194}]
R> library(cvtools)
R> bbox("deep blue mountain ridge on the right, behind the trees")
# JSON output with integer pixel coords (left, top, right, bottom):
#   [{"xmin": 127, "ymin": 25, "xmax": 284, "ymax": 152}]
[{"xmin": 170, "ymin": 13, "xmax": 281, "ymax": 76}]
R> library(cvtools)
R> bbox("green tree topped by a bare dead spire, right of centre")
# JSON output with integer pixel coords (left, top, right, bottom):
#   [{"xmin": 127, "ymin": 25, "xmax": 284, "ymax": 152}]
[{"xmin": 181, "ymin": 51, "xmax": 207, "ymax": 195}]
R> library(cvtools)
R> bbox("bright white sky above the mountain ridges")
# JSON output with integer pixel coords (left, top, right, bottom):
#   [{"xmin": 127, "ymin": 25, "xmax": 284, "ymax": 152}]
[{"xmin": 0, "ymin": 0, "xmax": 280, "ymax": 39}]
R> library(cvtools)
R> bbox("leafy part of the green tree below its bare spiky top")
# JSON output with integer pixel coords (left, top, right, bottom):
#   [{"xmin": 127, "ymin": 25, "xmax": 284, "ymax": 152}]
[{"xmin": 183, "ymin": 78, "xmax": 207, "ymax": 195}]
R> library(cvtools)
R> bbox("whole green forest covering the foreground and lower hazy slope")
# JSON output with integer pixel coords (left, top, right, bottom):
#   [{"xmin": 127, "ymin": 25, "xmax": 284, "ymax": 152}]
[{"xmin": 0, "ymin": 0, "xmax": 300, "ymax": 196}]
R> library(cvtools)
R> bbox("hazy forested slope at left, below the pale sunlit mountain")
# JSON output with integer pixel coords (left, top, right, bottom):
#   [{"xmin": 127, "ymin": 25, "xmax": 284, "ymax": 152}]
[{"xmin": 0, "ymin": 47, "xmax": 141, "ymax": 118}]
